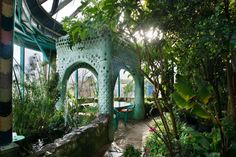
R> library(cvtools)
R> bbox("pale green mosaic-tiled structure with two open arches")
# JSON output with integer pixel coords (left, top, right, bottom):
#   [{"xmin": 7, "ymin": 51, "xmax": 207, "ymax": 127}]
[{"xmin": 56, "ymin": 31, "xmax": 144, "ymax": 139}]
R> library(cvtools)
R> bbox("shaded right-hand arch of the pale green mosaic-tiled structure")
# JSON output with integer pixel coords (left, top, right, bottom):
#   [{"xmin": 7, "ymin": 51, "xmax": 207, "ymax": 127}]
[{"xmin": 112, "ymin": 44, "xmax": 144, "ymax": 119}]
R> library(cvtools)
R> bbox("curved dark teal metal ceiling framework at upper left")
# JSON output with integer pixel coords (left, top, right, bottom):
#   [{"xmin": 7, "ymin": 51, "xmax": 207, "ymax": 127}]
[{"xmin": 14, "ymin": 0, "xmax": 80, "ymax": 53}]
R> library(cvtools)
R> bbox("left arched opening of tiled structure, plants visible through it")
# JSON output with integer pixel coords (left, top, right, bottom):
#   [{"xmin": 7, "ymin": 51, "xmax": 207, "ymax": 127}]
[{"xmin": 65, "ymin": 68, "xmax": 98, "ymax": 128}]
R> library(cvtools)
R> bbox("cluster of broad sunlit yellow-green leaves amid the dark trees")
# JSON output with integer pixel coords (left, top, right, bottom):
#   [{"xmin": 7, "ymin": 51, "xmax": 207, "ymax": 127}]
[{"xmin": 171, "ymin": 75, "xmax": 213, "ymax": 119}]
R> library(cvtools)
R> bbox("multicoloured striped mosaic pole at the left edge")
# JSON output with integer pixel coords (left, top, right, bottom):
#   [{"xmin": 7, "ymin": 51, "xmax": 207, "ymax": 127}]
[{"xmin": 0, "ymin": 0, "xmax": 14, "ymax": 146}]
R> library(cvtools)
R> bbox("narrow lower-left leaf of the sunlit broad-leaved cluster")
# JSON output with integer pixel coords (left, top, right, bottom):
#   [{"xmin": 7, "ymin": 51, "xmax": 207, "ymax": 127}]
[{"xmin": 171, "ymin": 92, "xmax": 194, "ymax": 110}]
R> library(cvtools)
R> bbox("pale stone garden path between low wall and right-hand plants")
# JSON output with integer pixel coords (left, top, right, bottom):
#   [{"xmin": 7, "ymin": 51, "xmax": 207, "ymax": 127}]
[{"xmin": 104, "ymin": 119, "xmax": 151, "ymax": 157}]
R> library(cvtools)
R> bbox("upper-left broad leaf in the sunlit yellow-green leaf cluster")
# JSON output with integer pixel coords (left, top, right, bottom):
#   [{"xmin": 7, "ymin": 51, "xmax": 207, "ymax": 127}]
[{"xmin": 174, "ymin": 76, "xmax": 195, "ymax": 101}]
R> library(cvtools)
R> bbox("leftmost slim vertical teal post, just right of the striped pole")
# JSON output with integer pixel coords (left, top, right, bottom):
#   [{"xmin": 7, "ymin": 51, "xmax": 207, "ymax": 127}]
[{"xmin": 20, "ymin": 47, "xmax": 25, "ymax": 100}]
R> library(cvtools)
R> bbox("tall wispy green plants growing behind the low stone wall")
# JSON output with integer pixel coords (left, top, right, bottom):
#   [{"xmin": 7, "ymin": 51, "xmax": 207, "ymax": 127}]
[{"xmin": 13, "ymin": 62, "xmax": 98, "ymax": 140}]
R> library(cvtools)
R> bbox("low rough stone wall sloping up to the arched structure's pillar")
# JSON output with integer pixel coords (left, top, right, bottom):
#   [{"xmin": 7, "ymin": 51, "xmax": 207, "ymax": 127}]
[{"xmin": 31, "ymin": 115, "xmax": 111, "ymax": 157}]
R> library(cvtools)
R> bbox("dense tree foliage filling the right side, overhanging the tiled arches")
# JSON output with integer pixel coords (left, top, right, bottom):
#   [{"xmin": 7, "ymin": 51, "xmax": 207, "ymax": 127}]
[{"xmin": 64, "ymin": 0, "xmax": 236, "ymax": 156}]
